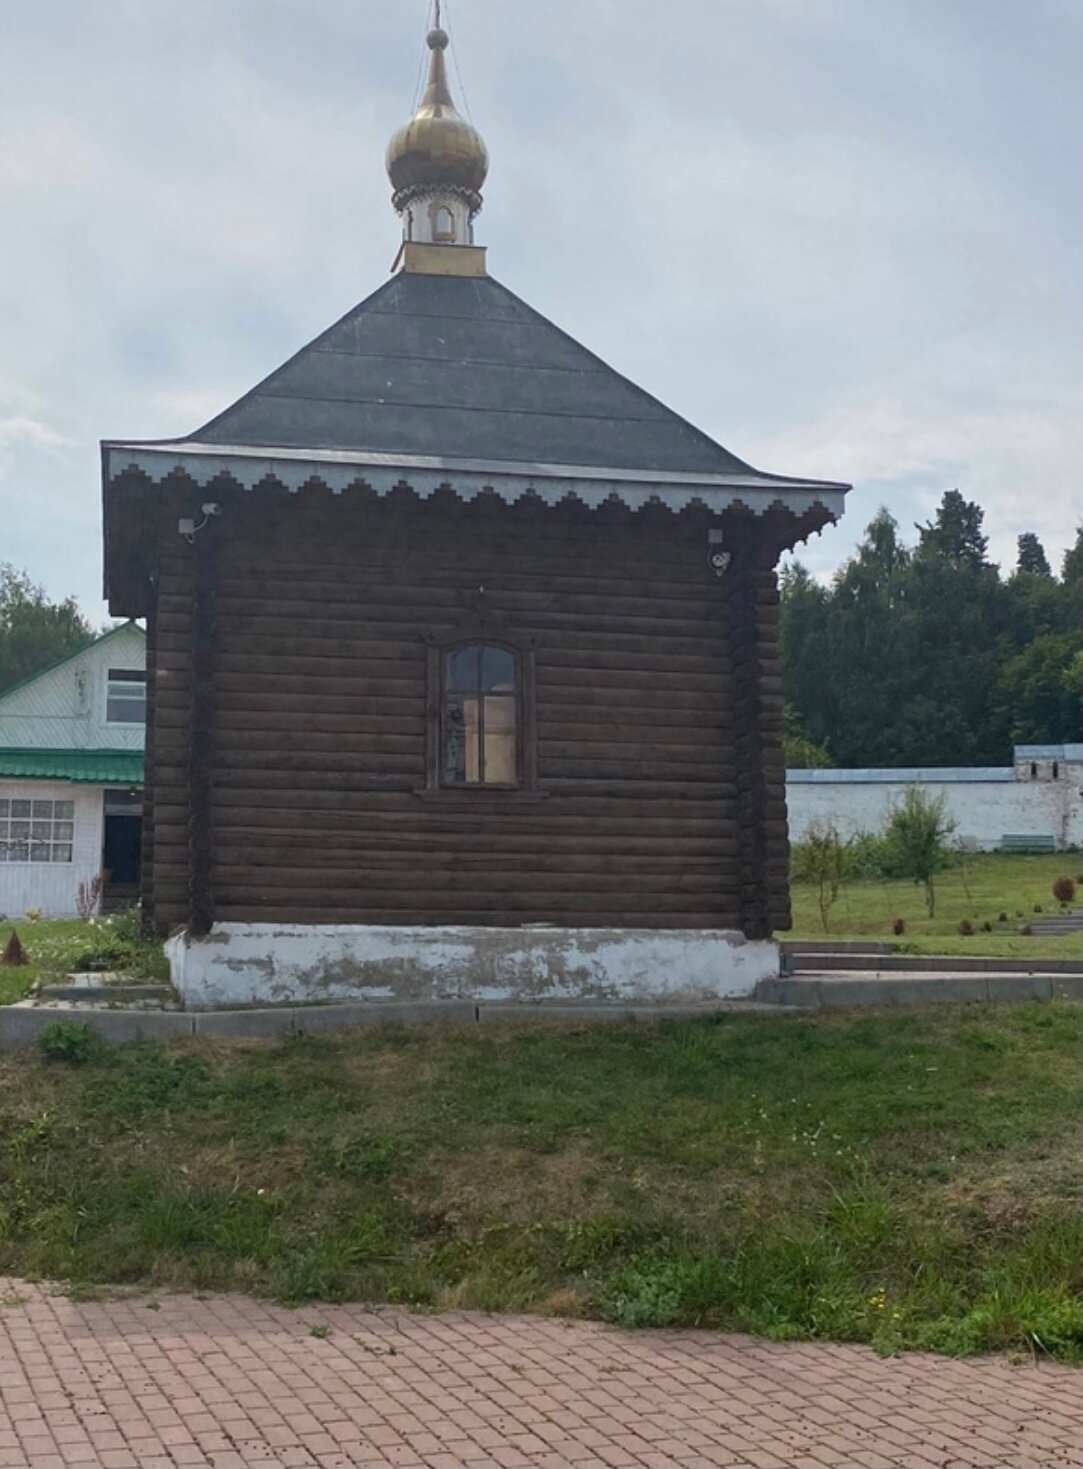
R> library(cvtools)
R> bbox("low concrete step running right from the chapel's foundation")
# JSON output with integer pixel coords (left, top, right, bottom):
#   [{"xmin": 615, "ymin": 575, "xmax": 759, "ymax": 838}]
[{"xmin": 755, "ymin": 970, "xmax": 1083, "ymax": 1009}]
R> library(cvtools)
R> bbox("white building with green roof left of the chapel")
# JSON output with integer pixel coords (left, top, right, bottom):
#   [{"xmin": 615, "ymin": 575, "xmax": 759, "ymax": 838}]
[{"xmin": 0, "ymin": 623, "xmax": 147, "ymax": 918}]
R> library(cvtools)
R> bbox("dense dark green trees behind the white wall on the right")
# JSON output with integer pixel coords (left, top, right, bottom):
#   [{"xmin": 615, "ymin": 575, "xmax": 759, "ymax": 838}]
[{"xmin": 780, "ymin": 489, "xmax": 1083, "ymax": 768}]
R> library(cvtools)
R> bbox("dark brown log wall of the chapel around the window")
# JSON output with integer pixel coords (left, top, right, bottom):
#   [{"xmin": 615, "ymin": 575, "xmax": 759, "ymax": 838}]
[{"xmin": 139, "ymin": 486, "xmax": 788, "ymax": 936}]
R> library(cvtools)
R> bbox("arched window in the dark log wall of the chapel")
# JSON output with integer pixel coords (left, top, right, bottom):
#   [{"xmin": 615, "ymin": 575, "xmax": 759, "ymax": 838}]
[{"xmin": 439, "ymin": 643, "xmax": 520, "ymax": 786}]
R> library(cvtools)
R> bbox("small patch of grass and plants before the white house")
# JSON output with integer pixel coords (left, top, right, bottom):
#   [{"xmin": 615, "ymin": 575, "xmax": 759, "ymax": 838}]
[{"xmin": 0, "ymin": 914, "xmax": 168, "ymax": 1005}]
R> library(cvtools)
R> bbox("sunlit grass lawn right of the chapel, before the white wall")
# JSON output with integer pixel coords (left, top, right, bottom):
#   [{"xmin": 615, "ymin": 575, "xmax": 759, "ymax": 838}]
[{"xmin": 780, "ymin": 852, "xmax": 1083, "ymax": 961}]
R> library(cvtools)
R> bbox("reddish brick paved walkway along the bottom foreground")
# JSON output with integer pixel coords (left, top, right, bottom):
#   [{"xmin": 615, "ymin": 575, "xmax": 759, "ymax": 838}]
[{"xmin": 0, "ymin": 1281, "xmax": 1083, "ymax": 1469}]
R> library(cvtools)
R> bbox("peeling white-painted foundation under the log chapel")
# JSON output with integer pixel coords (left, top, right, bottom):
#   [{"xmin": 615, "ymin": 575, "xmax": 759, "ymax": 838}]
[{"xmin": 166, "ymin": 923, "xmax": 779, "ymax": 1009}]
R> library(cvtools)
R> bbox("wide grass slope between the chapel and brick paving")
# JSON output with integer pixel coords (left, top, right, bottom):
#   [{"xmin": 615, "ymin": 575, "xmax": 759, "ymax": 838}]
[{"xmin": 0, "ymin": 1005, "xmax": 1083, "ymax": 1360}]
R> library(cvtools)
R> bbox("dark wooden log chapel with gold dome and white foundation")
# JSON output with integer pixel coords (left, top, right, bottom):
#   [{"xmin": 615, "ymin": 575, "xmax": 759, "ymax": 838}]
[{"xmin": 103, "ymin": 28, "xmax": 848, "ymax": 1005}]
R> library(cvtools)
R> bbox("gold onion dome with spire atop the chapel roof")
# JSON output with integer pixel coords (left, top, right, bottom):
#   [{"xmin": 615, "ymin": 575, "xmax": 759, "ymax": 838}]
[{"xmin": 388, "ymin": 28, "xmax": 489, "ymax": 213}]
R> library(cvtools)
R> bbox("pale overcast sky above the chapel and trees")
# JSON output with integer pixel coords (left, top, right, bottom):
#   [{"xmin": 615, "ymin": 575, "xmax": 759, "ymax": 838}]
[{"xmin": 0, "ymin": 0, "xmax": 1083, "ymax": 618}]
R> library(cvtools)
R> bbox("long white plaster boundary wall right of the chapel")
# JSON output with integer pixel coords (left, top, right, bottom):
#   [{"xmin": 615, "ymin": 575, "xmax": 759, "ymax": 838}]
[{"xmin": 786, "ymin": 745, "xmax": 1083, "ymax": 852}]
